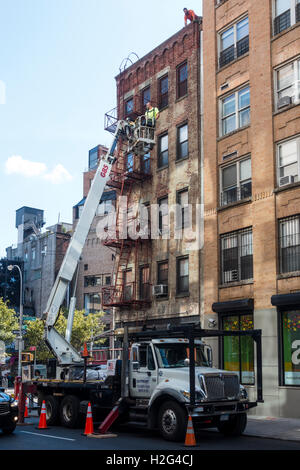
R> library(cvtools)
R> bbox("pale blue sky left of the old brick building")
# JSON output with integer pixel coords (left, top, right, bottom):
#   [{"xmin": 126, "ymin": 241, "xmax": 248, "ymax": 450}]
[{"xmin": 0, "ymin": 0, "xmax": 202, "ymax": 257}]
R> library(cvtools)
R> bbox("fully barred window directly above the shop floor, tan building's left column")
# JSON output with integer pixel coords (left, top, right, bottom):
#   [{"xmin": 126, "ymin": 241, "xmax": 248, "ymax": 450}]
[{"xmin": 221, "ymin": 228, "xmax": 253, "ymax": 284}]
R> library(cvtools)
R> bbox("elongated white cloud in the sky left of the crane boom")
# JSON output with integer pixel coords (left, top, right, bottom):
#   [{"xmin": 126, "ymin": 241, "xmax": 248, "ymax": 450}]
[{"xmin": 5, "ymin": 155, "xmax": 72, "ymax": 184}]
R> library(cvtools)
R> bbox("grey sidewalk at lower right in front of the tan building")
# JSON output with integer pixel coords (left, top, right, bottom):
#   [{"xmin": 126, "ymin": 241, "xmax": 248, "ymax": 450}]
[{"xmin": 244, "ymin": 416, "xmax": 300, "ymax": 445}]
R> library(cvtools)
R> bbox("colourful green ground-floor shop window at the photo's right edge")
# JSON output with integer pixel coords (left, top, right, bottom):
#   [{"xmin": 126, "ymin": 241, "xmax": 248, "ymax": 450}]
[{"xmin": 281, "ymin": 309, "xmax": 300, "ymax": 387}]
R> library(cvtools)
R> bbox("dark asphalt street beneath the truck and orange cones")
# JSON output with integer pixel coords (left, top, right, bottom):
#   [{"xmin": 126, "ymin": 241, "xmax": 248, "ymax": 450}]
[{"xmin": 0, "ymin": 418, "xmax": 300, "ymax": 452}]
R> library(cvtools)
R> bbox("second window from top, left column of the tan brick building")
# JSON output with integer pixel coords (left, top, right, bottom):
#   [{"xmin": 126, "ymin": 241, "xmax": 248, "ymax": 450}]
[{"xmin": 220, "ymin": 87, "xmax": 250, "ymax": 135}]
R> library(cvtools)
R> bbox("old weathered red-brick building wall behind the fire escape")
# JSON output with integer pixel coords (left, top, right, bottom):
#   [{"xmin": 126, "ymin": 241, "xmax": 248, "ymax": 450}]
[{"xmin": 103, "ymin": 22, "xmax": 201, "ymax": 325}]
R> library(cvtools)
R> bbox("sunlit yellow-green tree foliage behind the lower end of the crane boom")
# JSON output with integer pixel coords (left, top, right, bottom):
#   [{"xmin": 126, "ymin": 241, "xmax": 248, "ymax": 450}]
[{"xmin": 24, "ymin": 310, "xmax": 104, "ymax": 361}]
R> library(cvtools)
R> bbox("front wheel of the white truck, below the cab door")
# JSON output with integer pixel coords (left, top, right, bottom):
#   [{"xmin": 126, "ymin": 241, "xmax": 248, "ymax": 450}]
[{"xmin": 158, "ymin": 400, "xmax": 187, "ymax": 442}]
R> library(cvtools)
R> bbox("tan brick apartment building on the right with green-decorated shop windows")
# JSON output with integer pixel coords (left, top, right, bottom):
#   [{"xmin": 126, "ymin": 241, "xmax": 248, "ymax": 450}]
[{"xmin": 203, "ymin": 0, "xmax": 300, "ymax": 418}]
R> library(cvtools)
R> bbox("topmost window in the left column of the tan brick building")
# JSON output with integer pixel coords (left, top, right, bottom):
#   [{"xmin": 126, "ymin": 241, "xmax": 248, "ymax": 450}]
[{"xmin": 219, "ymin": 17, "xmax": 249, "ymax": 67}]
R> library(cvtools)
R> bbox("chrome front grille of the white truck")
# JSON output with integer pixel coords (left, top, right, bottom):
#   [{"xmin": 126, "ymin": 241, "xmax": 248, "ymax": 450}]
[{"xmin": 199, "ymin": 373, "xmax": 240, "ymax": 400}]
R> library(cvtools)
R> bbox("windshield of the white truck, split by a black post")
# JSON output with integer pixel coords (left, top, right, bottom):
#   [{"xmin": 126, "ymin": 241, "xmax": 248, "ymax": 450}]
[{"xmin": 155, "ymin": 343, "xmax": 209, "ymax": 368}]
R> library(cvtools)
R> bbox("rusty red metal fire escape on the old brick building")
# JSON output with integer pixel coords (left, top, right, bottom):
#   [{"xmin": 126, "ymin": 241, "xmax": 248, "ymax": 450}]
[{"xmin": 102, "ymin": 96, "xmax": 154, "ymax": 309}]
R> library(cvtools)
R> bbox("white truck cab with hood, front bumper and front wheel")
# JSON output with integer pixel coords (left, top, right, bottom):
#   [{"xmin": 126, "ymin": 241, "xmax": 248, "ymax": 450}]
[{"xmin": 128, "ymin": 338, "xmax": 255, "ymax": 441}]
